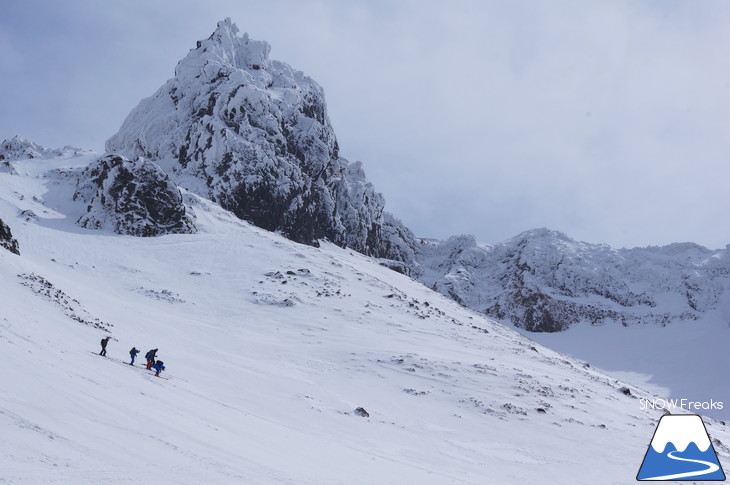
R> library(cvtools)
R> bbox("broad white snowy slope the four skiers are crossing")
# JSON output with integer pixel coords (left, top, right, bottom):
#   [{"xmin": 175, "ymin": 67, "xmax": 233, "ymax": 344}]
[{"xmin": 0, "ymin": 155, "xmax": 730, "ymax": 484}]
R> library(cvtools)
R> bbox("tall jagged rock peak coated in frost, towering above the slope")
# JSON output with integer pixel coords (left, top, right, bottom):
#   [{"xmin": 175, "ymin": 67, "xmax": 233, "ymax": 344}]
[{"xmin": 106, "ymin": 19, "xmax": 415, "ymax": 261}]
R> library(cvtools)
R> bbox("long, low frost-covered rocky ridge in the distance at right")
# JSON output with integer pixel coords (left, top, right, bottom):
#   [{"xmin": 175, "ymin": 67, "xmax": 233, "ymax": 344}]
[{"xmin": 418, "ymin": 229, "xmax": 730, "ymax": 332}]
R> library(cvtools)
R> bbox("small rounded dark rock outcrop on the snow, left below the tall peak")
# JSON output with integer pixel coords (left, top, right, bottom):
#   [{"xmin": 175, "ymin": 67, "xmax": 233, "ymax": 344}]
[{"xmin": 74, "ymin": 155, "xmax": 196, "ymax": 237}]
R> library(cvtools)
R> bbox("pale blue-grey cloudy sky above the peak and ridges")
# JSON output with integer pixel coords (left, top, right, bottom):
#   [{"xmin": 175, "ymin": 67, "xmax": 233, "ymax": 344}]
[{"xmin": 0, "ymin": 0, "xmax": 730, "ymax": 249}]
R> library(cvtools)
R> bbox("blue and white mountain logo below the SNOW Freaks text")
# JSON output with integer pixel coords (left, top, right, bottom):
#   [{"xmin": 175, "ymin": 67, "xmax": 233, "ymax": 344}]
[{"xmin": 636, "ymin": 414, "xmax": 725, "ymax": 481}]
